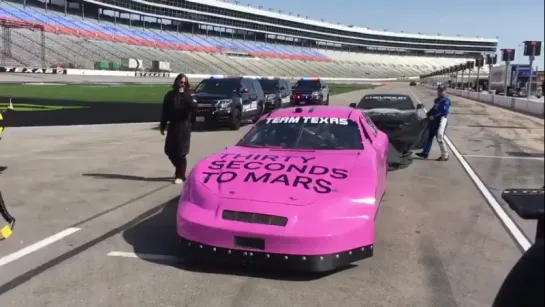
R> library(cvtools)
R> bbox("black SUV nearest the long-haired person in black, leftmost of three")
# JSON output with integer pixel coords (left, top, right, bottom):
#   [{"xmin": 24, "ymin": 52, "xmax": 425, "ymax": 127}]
[{"xmin": 193, "ymin": 77, "xmax": 265, "ymax": 130}]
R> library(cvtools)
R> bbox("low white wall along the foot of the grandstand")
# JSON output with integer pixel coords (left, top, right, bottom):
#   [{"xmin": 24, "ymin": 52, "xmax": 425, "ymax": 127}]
[{"xmin": 0, "ymin": 67, "xmax": 419, "ymax": 83}]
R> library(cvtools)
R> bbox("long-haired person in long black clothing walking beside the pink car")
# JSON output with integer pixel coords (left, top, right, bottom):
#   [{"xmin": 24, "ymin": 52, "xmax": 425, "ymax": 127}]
[{"xmin": 160, "ymin": 74, "xmax": 197, "ymax": 184}]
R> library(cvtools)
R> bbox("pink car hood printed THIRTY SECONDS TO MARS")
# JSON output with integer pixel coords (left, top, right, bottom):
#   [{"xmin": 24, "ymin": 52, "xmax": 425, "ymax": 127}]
[{"xmin": 192, "ymin": 146, "xmax": 374, "ymax": 206}]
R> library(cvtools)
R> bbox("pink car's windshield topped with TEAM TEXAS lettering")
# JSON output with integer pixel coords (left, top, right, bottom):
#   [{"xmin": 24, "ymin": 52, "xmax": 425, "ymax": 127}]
[{"xmin": 237, "ymin": 116, "xmax": 363, "ymax": 150}]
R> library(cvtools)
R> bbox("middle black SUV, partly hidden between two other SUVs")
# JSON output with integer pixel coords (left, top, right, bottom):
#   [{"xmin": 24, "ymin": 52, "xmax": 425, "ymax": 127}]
[{"xmin": 258, "ymin": 77, "xmax": 291, "ymax": 112}]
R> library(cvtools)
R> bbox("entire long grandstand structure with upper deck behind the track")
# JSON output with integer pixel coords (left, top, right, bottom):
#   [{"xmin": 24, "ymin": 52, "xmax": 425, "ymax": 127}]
[{"xmin": 0, "ymin": 0, "xmax": 497, "ymax": 79}]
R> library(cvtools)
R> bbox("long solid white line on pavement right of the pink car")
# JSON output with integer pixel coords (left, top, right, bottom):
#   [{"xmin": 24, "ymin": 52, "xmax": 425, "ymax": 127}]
[{"xmin": 409, "ymin": 89, "xmax": 532, "ymax": 251}]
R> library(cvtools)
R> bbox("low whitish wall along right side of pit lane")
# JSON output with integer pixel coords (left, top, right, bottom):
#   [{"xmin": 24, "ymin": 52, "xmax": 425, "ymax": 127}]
[{"xmin": 426, "ymin": 85, "xmax": 545, "ymax": 117}]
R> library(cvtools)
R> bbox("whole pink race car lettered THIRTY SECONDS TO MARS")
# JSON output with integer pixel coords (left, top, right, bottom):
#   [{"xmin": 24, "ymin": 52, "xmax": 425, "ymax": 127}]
[{"xmin": 176, "ymin": 106, "xmax": 388, "ymax": 271}]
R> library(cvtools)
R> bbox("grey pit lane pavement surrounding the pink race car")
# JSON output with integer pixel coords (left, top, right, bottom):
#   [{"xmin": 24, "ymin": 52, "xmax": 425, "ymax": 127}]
[{"xmin": 0, "ymin": 85, "xmax": 543, "ymax": 307}]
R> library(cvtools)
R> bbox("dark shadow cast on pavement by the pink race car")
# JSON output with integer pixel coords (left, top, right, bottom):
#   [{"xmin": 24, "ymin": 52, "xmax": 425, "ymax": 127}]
[{"xmin": 123, "ymin": 197, "xmax": 355, "ymax": 281}]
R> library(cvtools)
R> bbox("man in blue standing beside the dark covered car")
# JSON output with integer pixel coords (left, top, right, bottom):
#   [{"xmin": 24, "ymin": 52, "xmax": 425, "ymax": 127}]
[{"xmin": 416, "ymin": 85, "xmax": 450, "ymax": 161}]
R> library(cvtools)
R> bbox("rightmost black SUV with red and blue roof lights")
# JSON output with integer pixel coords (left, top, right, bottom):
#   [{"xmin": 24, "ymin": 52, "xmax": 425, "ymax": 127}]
[{"xmin": 291, "ymin": 78, "xmax": 330, "ymax": 106}]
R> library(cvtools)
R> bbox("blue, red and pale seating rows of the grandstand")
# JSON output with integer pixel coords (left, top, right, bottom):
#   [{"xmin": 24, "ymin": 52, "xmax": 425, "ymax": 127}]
[{"xmin": 0, "ymin": 1, "xmax": 490, "ymax": 78}]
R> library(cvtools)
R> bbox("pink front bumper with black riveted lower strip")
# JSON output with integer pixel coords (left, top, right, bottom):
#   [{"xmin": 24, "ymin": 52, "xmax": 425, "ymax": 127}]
[{"xmin": 176, "ymin": 202, "xmax": 374, "ymax": 272}]
